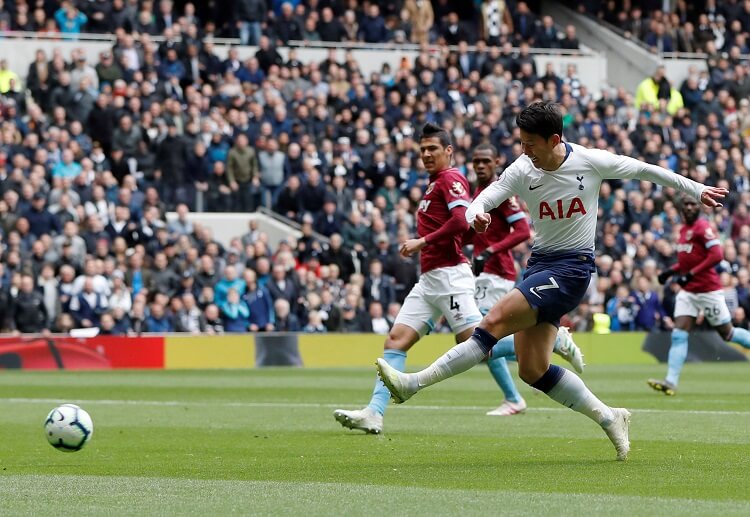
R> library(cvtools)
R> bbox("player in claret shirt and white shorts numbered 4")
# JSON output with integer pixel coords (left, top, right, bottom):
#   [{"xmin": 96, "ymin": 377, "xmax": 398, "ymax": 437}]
[{"xmin": 333, "ymin": 123, "xmax": 482, "ymax": 434}]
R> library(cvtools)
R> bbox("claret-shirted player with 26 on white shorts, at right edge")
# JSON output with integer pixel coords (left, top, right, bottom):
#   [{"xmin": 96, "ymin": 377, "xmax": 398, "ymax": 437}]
[{"xmin": 648, "ymin": 197, "xmax": 750, "ymax": 395}]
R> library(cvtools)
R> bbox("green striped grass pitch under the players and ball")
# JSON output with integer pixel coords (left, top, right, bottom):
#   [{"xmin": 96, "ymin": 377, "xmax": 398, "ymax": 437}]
[{"xmin": 0, "ymin": 364, "xmax": 750, "ymax": 516}]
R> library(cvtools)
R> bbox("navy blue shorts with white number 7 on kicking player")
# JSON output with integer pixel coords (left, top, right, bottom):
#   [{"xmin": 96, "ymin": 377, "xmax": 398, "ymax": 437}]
[{"xmin": 516, "ymin": 251, "xmax": 595, "ymax": 327}]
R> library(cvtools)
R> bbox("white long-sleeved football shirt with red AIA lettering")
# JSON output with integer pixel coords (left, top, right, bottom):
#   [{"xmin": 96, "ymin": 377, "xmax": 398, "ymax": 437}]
[{"xmin": 466, "ymin": 143, "xmax": 705, "ymax": 253}]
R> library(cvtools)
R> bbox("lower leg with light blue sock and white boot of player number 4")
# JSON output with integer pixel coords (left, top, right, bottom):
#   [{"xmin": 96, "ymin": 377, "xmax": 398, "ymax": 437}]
[{"xmin": 333, "ymin": 323, "xmax": 419, "ymax": 434}]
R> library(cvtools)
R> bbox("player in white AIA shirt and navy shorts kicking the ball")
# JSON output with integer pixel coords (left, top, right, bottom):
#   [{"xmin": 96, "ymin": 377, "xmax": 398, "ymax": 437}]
[{"xmin": 377, "ymin": 102, "xmax": 728, "ymax": 460}]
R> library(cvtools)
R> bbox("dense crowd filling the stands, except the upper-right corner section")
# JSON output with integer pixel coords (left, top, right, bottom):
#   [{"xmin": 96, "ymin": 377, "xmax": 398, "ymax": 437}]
[{"xmin": 0, "ymin": 0, "xmax": 750, "ymax": 334}]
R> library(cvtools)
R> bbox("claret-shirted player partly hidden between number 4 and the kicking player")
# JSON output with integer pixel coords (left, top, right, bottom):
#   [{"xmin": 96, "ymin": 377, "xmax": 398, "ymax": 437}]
[{"xmin": 471, "ymin": 144, "xmax": 584, "ymax": 416}]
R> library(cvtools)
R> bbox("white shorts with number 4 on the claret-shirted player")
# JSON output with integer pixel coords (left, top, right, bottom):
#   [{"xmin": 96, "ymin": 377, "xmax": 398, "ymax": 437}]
[{"xmin": 394, "ymin": 264, "xmax": 482, "ymax": 337}]
